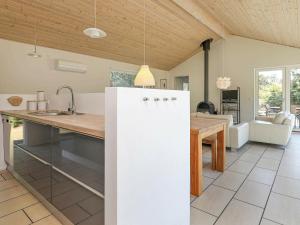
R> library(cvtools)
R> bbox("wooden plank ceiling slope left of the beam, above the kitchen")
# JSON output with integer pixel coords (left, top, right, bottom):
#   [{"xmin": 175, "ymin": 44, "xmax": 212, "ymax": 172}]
[{"xmin": 0, "ymin": 0, "xmax": 219, "ymax": 70}]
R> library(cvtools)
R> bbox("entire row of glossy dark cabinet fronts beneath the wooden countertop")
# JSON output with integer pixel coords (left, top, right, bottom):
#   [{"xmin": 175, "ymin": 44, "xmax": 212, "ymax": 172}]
[{"xmin": 12, "ymin": 118, "xmax": 104, "ymax": 225}]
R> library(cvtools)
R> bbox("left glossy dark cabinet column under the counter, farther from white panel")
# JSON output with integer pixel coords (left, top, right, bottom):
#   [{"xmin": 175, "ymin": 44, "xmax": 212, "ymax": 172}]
[{"xmin": 13, "ymin": 121, "xmax": 52, "ymax": 200}]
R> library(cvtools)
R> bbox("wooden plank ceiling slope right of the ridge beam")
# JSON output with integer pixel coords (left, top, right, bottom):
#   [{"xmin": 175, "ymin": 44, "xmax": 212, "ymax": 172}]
[{"xmin": 193, "ymin": 0, "xmax": 300, "ymax": 47}]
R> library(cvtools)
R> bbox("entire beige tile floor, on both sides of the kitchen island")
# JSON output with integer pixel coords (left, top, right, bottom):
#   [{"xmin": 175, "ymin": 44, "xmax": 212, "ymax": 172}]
[{"xmin": 0, "ymin": 134, "xmax": 300, "ymax": 225}]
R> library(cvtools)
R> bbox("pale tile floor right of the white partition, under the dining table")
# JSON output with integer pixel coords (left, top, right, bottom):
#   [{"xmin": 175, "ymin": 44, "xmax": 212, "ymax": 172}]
[{"xmin": 191, "ymin": 133, "xmax": 300, "ymax": 225}]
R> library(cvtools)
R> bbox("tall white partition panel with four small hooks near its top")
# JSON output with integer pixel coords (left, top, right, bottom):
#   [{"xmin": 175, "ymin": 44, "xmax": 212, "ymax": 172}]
[{"xmin": 105, "ymin": 88, "xmax": 190, "ymax": 225}]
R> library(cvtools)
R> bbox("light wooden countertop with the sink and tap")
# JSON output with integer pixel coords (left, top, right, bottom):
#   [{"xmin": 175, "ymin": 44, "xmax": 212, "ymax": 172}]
[{"xmin": 0, "ymin": 110, "xmax": 105, "ymax": 139}]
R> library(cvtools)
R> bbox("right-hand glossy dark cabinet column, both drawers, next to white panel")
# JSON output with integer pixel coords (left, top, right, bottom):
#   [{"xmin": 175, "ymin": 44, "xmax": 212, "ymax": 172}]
[{"xmin": 52, "ymin": 128, "xmax": 104, "ymax": 225}]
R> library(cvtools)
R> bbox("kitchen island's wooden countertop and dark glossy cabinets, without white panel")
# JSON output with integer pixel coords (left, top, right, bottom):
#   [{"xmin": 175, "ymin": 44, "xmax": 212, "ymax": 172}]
[{"xmin": 1, "ymin": 111, "xmax": 105, "ymax": 225}]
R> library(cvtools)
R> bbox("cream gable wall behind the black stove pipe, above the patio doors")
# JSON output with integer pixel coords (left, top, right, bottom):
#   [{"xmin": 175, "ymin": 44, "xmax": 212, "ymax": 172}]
[{"xmin": 170, "ymin": 36, "xmax": 300, "ymax": 121}]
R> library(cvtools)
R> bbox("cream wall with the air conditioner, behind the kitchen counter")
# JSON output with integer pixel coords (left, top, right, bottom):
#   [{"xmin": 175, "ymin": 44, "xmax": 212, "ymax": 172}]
[{"xmin": 0, "ymin": 39, "xmax": 168, "ymax": 94}]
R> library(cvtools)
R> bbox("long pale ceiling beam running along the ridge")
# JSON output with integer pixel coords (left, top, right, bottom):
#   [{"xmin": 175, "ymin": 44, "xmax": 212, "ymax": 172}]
[{"xmin": 172, "ymin": 0, "xmax": 229, "ymax": 39}]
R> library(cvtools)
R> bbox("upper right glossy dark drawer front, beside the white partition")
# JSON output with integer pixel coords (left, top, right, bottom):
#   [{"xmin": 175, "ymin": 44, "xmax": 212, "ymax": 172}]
[{"xmin": 52, "ymin": 128, "xmax": 104, "ymax": 195}]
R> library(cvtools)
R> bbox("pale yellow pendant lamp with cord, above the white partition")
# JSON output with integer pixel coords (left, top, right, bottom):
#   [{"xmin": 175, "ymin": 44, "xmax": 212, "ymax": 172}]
[{"xmin": 134, "ymin": 0, "xmax": 155, "ymax": 87}]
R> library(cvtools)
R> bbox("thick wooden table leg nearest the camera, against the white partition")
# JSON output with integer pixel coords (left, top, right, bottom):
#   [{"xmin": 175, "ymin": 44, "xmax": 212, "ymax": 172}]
[{"xmin": 190, "ymin": 133, "xmax": 202, "ymax": 196}]
